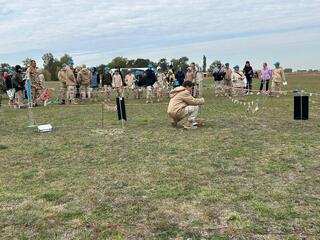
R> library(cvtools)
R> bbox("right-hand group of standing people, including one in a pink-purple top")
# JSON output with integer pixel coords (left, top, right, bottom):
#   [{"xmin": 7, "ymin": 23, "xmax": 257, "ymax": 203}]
[{"xmin": 212, "ymin": 61, "xmax": 287, "ymax": 97}]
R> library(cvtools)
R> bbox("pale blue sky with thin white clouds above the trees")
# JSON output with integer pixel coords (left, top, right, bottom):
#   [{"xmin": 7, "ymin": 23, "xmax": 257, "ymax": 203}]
[{"xmin": 0, "ymin": 0, "xmax": 320, "ymax": 69}]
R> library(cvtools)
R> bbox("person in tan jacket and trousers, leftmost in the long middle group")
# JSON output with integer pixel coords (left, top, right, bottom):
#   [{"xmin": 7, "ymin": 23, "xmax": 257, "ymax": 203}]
[{"xmin": 58, "ymin": 65, "xmax": 77, "ymax": 104}]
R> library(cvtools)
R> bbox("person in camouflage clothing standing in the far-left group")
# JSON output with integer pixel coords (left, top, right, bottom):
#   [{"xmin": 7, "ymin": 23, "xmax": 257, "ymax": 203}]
[{"xmin": 26, "ymin": 60, "xmax": 43, "ymax": 105}]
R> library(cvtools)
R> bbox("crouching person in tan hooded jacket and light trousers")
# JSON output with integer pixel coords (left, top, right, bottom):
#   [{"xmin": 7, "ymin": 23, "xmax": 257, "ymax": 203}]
[{"xmin": 167, "ymin": 81, "xmax": 204, "ymax": 129}]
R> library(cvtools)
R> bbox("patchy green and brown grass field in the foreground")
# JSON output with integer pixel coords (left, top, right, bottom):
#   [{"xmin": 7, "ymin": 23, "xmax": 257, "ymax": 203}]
[{"xmin": 0, "ymin": 75, "xmax": 320, "ymax": 239}]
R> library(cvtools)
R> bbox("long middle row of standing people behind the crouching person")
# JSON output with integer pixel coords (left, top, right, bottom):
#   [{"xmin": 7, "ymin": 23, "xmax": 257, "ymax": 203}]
[{"xmin": 58, "ymin": 63, "xmax": 203, "ymax": 104}]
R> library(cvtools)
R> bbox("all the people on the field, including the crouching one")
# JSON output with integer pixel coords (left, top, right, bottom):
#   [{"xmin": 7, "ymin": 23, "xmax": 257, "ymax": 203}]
[{"xmin": 0, "ymin": 60, "xmax": 287, "ymax": 127}]
